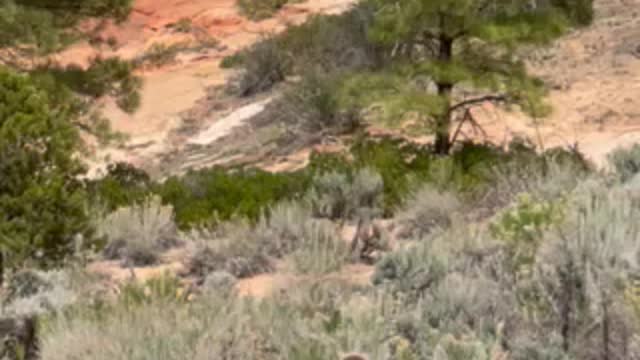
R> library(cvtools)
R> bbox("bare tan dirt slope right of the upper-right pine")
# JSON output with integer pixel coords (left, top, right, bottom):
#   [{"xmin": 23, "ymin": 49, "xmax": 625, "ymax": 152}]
[{"xmin": 466, "ymin": 0, "xmax": 640, "ymax": 165}]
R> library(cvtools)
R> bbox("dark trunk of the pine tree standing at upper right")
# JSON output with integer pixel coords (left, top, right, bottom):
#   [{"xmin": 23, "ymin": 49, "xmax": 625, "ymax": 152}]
[{"xmin": 434, "ymin": 34, "xmax": 453, "ymax": 155}]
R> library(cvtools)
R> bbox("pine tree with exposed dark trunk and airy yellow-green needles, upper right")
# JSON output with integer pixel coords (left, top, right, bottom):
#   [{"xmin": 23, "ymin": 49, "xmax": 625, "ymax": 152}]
[{"xmin": 345, "ymin": 0, "xmax": 591, "ymax": 154}]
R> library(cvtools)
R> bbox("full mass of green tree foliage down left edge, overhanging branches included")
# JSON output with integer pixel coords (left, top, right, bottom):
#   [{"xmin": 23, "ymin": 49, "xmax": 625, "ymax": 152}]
[{"xmin": 0, "ymin": 0, "xmax": 134, "ymax": 281}]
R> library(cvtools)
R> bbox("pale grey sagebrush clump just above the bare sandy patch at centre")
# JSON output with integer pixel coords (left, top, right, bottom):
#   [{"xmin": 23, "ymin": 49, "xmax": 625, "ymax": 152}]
[{"xmin": 186, "ymin": 202, "xmax": 349, "ymax": 279}]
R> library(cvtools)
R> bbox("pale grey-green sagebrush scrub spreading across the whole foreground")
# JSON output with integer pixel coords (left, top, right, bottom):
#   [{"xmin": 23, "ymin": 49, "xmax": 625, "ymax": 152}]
[{"xmin": 5, "ymin": 141, "xmax": 640, "ymax": 359}]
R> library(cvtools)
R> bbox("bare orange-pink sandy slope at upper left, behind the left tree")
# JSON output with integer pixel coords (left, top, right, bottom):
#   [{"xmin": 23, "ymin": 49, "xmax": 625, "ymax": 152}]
[{"xmin": 57, "ymin": 0, "xmax": 353, "ymax": 176}]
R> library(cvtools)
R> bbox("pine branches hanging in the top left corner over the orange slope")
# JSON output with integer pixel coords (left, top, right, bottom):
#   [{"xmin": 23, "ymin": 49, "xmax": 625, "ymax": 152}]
[{"xmin": 0, "ymin": 0, "xmax": 141, "ymax": 119}]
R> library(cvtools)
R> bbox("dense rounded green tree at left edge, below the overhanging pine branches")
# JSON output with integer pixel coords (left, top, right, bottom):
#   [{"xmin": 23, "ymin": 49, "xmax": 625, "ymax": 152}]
[{"xmin": 0, "ymin": 69, "xmax": 88, "ymax": 266}]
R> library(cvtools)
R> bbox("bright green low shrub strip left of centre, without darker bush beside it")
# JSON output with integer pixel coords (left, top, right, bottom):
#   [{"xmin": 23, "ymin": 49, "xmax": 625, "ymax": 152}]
[{"xmin": 154, "ymin": 168, "xmax": 309, "ymax": 227}]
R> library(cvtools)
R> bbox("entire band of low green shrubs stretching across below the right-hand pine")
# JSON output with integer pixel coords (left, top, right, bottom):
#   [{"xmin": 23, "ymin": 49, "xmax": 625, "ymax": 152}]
[{"xmin": 89, "ymin": 138, "xmax": 592, "ymax": 235}]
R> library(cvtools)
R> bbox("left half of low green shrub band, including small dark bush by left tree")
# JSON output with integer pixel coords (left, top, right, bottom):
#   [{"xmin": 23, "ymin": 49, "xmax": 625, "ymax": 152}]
[{"xmin": 88, "ymin": 163, "xmax": 310, "ymax": 228}]
